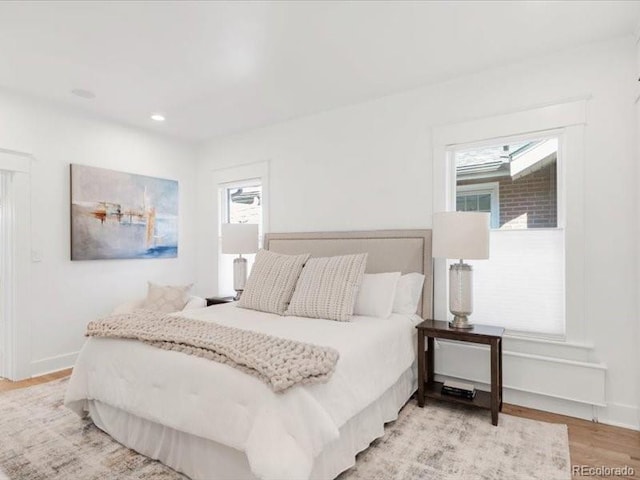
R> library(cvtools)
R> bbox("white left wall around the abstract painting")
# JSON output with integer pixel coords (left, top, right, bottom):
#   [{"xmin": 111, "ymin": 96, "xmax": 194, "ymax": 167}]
[{"xmin": 0, "ymin": 91, "xmax": 196, "ymax": 375}]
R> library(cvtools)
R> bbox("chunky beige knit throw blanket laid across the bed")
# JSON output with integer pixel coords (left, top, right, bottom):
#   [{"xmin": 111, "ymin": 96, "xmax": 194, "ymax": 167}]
[{"xmin": 85, "ymin": 310, "xmax": 339, "ymax": 392}]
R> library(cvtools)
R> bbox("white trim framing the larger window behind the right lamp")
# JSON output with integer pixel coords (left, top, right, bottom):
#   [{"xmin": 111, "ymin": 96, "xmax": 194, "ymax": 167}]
[{"xmin": 432, "ymin": 98, "xmax": 589, "ymax": 343}]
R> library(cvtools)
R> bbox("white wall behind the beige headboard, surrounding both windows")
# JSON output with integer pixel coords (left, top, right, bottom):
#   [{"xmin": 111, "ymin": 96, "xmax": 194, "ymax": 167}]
[{"xmin": 198, "ymin": 38, "xmax": 640, "ymax": 428}]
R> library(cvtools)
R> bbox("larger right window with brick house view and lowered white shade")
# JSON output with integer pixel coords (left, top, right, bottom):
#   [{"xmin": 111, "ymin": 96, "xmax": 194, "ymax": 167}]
[{"xmin": 451, "ymin": 136, "xmax": 565, "ymax": 336}]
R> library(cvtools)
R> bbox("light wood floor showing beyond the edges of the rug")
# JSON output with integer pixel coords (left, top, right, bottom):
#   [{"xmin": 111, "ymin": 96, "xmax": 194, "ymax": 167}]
[{"xmin": 0, "ymin": 369, "xmax": 640, "ymax": 480}]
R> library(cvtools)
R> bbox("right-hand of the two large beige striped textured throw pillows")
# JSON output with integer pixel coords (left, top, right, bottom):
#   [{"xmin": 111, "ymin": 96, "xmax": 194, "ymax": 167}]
[{"xmin": 286, "ymin": 253, "xmax": 367, "ymax": 322}]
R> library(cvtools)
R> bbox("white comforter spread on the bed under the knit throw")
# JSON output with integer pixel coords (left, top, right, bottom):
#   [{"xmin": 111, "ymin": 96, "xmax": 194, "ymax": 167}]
[{"xmin": 65, "ymin": 304, "xmax": 420, "ymax": 480}]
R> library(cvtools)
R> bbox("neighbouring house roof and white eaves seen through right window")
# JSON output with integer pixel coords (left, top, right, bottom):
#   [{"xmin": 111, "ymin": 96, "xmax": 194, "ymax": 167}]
[{"xmin": 456, "ymin": 142, "xmax": 558, "ymax": 183}]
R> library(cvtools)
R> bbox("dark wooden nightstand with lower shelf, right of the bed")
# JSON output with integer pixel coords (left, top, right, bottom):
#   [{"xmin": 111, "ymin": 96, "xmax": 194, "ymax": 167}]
[{"xmin": 416, "ymin": 320, "xmax": 504, "ymax": 425}]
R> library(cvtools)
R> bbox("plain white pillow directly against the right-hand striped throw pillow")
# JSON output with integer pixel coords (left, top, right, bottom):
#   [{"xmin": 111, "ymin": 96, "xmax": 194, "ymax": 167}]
[{"xmin": 353, "ymin": 272, "xmax": 400, "ymax": 318}]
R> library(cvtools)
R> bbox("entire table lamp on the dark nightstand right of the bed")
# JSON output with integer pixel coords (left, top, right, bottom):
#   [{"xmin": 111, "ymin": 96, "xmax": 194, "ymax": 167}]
[{"xmin": 432, "ymin": 212, "xmax": 490, "ymax": 328}]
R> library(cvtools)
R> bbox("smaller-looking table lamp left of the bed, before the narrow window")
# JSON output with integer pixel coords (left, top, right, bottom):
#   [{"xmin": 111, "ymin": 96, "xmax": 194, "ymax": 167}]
[{"xmin": 222, "ymin": 223, "xmax": 258, "ymax": 300}]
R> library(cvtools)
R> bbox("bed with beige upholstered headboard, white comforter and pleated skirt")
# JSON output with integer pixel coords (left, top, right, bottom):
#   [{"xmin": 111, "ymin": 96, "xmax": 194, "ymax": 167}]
[{"xmin": 65, "ymin": 230, "xmax": 432, "ymax": 480}]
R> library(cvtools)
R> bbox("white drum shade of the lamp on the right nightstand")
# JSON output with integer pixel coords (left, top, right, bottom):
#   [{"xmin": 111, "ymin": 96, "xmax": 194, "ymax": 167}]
[{"xmin": 432, "ymin": 212, "xmax": 490, "ymax": 260}]
